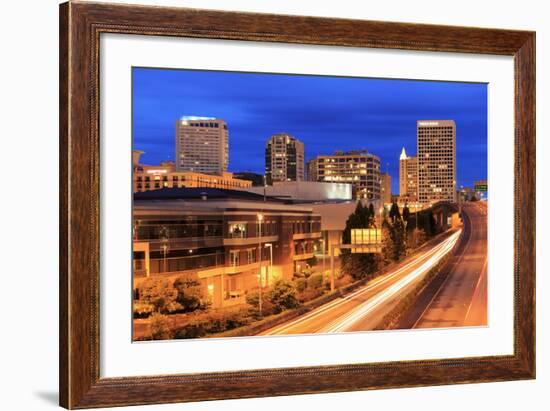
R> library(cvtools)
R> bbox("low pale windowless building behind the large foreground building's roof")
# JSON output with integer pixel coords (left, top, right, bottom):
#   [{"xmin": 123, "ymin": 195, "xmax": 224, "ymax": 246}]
[{"xmin": 246, "ymin": 181, "xmax": 353, "ymax": 202}]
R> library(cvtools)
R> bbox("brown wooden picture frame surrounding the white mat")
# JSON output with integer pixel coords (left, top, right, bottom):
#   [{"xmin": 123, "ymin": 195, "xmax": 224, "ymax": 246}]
[{"xmin": 59, "ymin": 2, "xmax": 536, "ymax": 409}]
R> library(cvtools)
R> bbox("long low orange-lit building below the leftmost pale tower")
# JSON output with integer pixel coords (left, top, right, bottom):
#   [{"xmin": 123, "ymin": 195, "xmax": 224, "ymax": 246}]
[{"xmin": 132, "ymin": 150, "xmax": 252, "ymax": 193}]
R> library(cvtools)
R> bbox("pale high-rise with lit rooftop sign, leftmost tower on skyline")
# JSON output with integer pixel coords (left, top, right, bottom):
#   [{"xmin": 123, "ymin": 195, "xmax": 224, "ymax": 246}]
[{"xmin": 176, "ymin": 116, "xmax": 229, "ymax": 175}]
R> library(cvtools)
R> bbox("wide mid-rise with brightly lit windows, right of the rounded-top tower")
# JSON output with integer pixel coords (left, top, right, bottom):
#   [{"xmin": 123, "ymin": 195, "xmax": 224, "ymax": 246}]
[{"xmin": 308, "ymin": 150, "xmax": 381, "ymax": 200}]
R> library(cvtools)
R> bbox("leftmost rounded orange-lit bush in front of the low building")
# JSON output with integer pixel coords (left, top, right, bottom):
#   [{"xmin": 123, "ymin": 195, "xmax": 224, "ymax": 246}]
[{"xmin": 138, "ymin": 277, "xmax": 182, "ymax": 314}]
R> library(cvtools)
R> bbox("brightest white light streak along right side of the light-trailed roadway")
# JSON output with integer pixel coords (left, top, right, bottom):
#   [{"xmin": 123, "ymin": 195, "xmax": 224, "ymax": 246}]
[{"xmin": 320, "ymin": 230, "xmax": 461, "ymax": 333}]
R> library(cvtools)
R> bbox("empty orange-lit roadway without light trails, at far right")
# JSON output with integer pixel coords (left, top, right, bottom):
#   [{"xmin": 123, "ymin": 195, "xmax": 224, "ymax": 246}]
[{"xmin": 413, "ymin": 201, "xmax": 487, "ymax": 328}]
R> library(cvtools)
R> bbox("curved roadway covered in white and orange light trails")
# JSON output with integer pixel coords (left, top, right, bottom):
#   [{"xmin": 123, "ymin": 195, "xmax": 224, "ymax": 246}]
[{"xmin": 260, "ymin": 230, "xmax": 461, "ymax": 335}]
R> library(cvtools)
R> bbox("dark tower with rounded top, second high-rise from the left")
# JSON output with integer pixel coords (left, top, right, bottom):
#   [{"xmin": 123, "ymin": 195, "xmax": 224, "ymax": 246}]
[{"xmin": 265, "ymin": 133, "xmax": 304, "ymax": 185}]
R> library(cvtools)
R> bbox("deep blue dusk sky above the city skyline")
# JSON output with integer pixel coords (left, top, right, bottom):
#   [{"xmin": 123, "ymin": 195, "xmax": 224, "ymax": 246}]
[{"xmin": 133, "ymin": 68, "xmax": 487, "ymax": 193}]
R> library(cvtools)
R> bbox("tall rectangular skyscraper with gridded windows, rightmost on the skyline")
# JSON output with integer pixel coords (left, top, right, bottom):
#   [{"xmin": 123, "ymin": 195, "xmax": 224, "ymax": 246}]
[{"xmin": 416, "ymin": 120, "xmax": 456, "ymax": 203}]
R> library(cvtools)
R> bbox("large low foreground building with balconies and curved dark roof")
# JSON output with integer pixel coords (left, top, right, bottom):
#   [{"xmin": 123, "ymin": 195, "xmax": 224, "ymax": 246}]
[{"xmin": 133, "ymin": 188, "xmax": 321, "ymax": 307}]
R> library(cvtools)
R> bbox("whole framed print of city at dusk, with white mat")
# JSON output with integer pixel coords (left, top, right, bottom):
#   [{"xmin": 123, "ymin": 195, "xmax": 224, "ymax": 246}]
[{"xmin": 60, "ymin": 2, "xmax": 535, "ymax": 408}]
